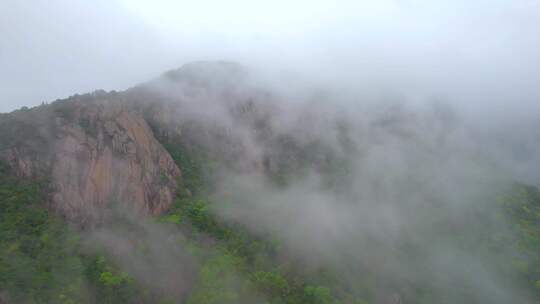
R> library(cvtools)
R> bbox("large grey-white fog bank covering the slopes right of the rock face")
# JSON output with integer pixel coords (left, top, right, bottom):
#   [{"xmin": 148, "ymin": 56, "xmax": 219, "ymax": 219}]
[{"xmin": 110, "ymin": 58, "xmax": 540, "ymax": 303}]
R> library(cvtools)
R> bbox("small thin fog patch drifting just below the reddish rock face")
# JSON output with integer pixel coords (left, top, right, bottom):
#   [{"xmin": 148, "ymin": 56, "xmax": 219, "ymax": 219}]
[{"xmin": 83, "ymin": 210, "xmax": 199, "ymax": 302}]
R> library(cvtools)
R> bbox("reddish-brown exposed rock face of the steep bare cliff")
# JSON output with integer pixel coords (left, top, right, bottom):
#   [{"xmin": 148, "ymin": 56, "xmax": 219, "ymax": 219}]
[{"xmin": 52, "ymin": 104, "xmax": 180, "ymax": 223}]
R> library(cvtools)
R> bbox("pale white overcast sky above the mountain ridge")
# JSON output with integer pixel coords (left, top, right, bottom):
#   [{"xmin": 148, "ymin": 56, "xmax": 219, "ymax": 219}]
[{"xmin": 0, "ymin": 0, "xmax": 540, "ymax": 113}]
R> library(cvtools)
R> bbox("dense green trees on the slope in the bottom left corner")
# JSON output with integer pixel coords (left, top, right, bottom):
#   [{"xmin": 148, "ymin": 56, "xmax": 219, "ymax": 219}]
[{"xmin": 0, "ymin": 164, "xmax": 146, "ymax": 303}]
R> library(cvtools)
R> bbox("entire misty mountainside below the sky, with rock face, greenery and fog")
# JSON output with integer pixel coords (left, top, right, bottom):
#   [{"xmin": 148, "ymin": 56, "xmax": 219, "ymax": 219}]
[{"xmin": 0, "ymin": 61, "xmax": 540, "ymax": 304}]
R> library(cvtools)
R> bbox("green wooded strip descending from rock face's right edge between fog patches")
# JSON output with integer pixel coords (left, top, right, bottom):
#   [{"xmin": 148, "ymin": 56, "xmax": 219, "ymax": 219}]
[{"xmin": 162, "ymin": 144, "xmax": 344, "ymax": 304}]
